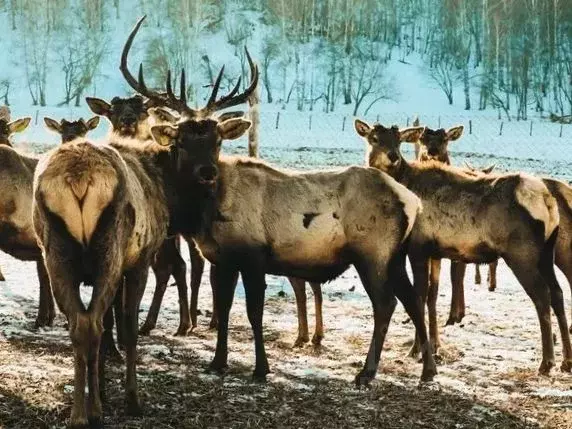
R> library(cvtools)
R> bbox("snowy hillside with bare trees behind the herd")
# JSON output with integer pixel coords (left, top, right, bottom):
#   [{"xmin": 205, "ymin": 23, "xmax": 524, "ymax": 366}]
[{"xmin": 0, "ymin": 0, "xmax": 572, "ymax": 121}]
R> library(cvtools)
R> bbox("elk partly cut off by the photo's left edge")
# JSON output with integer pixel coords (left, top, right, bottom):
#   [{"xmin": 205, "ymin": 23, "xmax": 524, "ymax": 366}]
[{"xmin": 0, "ymin": 114, "xmax": 106, "ymax": 332}]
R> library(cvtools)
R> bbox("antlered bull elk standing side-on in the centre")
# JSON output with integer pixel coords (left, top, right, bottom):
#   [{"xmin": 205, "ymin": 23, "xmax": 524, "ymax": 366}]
[{"xmin": 122, "ymin": 16, "xmax": 436, "ymax": 384}]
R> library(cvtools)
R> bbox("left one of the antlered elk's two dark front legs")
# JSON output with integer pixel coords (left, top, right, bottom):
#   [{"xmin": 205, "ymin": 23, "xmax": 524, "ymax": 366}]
[{"xmin": 209, "ymin": 263, "xmax": 238, "ymax": 373}]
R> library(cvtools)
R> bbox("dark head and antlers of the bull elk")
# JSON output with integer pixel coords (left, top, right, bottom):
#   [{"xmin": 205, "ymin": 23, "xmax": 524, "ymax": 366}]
[{"xmin": 120, "ymin": 16, "xmax": 258, "ymax": 189}]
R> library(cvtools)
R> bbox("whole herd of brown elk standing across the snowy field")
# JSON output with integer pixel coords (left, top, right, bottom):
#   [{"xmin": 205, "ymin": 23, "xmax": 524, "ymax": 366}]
[{"xmin": 0, "ymin": 17, "xmax": 572, "ymax": 427}]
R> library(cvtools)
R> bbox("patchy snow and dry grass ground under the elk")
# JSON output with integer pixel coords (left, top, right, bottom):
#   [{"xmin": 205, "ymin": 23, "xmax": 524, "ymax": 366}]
[{"xmin": 0, "ymin": 255, "xmax": 572, "ymax": 428}]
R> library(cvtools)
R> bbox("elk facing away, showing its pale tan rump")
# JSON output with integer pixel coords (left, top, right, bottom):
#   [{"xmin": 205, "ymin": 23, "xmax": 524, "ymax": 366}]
[{"xmin": 33, "ymin": 140, "xmax": 172, "ymax": 426}]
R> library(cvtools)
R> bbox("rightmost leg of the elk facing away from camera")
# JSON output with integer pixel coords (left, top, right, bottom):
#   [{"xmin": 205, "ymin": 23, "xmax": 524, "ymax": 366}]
[{"xmin": 125, "ymin": 264, "xmax": 149, "ymax": 416}]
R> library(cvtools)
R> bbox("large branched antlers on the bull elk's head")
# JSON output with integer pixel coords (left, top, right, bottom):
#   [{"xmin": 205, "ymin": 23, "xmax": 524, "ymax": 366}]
[{"xmin": 119, "ymin": 15, "xmax": 259, "ymax": 118}]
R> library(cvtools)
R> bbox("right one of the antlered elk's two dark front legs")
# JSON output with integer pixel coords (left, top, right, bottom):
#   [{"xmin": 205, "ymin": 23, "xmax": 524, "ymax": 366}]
[{"xmin": 241, "ymin": 267, "xmax": 270, "ymax": 381}]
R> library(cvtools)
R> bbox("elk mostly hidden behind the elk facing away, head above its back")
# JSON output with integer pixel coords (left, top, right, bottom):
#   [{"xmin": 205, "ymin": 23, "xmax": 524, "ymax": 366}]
[{"xmin": 86, "ymin": 93, "xmax": 204, "ymax": 335}]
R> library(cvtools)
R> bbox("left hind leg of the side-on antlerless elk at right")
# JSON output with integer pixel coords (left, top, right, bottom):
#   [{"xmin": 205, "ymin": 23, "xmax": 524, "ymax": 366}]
[{"xmin": 505, "ymin": 254, "xmax": 554, "ymax": 375}]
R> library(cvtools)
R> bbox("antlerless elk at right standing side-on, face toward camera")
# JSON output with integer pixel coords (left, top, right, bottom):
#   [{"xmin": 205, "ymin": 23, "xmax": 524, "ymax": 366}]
[{"xmin": 355, "ymin": 120, "xmax": 572, "ymax": 374}]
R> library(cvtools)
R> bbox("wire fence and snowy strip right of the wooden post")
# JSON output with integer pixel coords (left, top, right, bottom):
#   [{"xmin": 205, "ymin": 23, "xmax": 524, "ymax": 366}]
[{"xmin": 225, "ymin": 111, "xmax": 572, "ymax": 180}]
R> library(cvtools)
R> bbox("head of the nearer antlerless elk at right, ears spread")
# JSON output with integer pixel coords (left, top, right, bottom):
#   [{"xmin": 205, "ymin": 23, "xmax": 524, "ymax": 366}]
[{"xmin": 354, "ymin": 119, "xmax": 425, "ymax": 176}]
